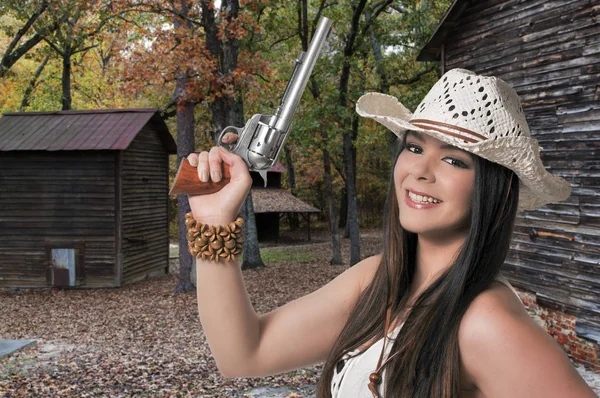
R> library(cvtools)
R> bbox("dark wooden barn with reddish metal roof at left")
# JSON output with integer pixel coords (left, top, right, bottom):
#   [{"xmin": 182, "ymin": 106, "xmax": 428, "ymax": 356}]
[{"xmin": 0, "ymin": 109, "xmax": 176, "ymax": 288}]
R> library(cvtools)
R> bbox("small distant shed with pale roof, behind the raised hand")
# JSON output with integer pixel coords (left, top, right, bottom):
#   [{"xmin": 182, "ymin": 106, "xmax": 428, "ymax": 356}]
[{"xmin": 250, "ymin": 163, "xmax": 321, "ymax": 241}]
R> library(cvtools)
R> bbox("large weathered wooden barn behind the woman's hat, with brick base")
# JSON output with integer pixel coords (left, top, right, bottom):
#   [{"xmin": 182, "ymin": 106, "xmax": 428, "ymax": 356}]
[{"xmin": 418, "ymin": 0, "xmax": 600, "ymax": 371}]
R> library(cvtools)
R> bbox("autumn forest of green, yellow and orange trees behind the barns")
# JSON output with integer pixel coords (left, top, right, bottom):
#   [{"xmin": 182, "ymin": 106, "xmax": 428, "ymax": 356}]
[{"xmin": 0, "ymin": 0, "xmax": 451, "ymax": 291}]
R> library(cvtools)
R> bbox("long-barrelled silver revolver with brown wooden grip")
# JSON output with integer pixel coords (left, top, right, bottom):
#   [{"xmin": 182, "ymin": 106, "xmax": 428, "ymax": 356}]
[{"xmin": 169, "ymin": 17, "xmax": 332, "ymax": 195}]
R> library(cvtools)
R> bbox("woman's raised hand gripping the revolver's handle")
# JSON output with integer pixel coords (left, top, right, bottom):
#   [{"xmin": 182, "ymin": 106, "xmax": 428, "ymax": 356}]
[{"xmin": 187, "ymin": 133, "xmax": 252, "ymax": 225}]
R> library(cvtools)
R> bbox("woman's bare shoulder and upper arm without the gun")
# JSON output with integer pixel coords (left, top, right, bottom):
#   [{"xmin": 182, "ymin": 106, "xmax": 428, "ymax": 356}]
[{"xmin": 458, "ymin": 283, "xmax": 594, "ymax": 397}]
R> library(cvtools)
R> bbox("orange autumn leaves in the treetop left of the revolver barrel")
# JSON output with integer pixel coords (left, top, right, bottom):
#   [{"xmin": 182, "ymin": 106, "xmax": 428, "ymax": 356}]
[{"xmin": 113, "ymin": 1, "xmax": 268, "ymax": 107}]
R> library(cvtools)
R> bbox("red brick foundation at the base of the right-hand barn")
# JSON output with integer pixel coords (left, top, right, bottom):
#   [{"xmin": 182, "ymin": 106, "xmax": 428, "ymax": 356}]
[{"xmin": 515, "ymin": 287, "xmax": 600, "ymax": 372}]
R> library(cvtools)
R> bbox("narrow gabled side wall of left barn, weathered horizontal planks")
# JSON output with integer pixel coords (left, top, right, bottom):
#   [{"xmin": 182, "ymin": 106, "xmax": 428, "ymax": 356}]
[{"xmin": 120, "ymin": 125, "xmax": 169, "ymax": 283}]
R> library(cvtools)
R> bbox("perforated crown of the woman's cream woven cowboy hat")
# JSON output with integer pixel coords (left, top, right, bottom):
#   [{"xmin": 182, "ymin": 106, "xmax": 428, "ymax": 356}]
[{"xmin": 410, "ymin": 69, "xmax": 531, "ymax": 143}]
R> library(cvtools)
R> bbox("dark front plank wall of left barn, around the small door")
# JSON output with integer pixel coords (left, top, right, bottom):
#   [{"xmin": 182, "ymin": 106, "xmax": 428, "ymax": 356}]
[{"xmin": 0, "ymin": 151, "xmax": 116, "ymax": 287}]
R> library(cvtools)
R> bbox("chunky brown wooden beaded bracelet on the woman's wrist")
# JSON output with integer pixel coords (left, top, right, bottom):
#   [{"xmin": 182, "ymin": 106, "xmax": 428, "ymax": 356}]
[{"xmin": 185, "ymin": 212, "xmax": 244, "ymax": 261}]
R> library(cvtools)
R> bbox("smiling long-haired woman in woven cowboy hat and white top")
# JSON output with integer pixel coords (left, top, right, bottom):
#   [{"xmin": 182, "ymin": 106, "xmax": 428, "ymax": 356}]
[{"xmin": 188, "ymin": 69, "xmax": 595, "ymax": 398}]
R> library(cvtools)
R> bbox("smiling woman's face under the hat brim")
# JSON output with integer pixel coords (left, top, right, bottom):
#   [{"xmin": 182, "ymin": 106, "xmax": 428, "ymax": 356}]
[{"xmin": 394, "ymin": 131, "xmax": 475, "ymax": 239}]
